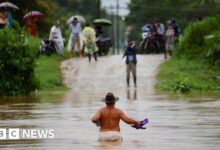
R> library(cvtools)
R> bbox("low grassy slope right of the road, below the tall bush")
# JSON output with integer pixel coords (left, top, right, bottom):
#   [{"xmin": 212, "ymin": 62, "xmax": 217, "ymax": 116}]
[{"xmin": 156, "ymin": 58, "xmax": 220, "ymax": 93}]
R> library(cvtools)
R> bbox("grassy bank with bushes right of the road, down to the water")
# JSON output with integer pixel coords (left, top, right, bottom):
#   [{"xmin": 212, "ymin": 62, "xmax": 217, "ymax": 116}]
[{"xmin": 157, "ymin": 16, "xmax": 220, "ymax": 93}]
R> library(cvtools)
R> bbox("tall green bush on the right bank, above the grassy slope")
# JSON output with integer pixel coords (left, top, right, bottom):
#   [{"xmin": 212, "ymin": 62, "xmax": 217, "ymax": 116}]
[{"xmin": 175, "ymin": 16, "xmax": 220, "ymax": 61}]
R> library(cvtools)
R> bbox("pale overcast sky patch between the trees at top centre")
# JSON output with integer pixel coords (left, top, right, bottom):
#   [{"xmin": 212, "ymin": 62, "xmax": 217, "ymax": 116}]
[{"xmin": 101, "ymin": 0, "xmax": 130, "ymax": 16}]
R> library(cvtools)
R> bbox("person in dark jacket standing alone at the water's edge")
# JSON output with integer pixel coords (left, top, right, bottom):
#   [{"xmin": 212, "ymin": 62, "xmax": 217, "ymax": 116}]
[{"xmin": 122, "ymin": 39, "xmax": 137, "ymax": 87}]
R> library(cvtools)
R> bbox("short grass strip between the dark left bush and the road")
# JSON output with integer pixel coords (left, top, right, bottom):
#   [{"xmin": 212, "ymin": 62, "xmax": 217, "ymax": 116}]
[{"xmin": 35, "ymin": 55, "xmax": 68, "ymax": 93}]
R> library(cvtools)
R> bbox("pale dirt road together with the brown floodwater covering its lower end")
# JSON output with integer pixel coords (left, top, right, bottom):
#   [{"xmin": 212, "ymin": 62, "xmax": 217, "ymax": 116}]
[{"xmin": 0, "ymin": 55, "xmax": 220, "ymax": 150}]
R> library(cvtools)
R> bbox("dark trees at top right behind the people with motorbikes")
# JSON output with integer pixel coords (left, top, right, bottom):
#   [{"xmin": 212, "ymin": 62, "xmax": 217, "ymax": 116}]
[{"xmin": 127, "ymin": 0, "xmax": 220, "ymax": 38}]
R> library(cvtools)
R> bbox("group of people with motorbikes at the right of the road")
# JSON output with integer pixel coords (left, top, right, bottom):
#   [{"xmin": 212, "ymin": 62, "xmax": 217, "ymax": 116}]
[{"xmin": 141, "ymin": 18, "xmax": 180, "ymax": 58}]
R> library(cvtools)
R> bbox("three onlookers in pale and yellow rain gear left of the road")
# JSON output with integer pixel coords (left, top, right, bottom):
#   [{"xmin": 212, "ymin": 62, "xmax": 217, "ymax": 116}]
[{"xmin": 49, "ymin": 17, "xmax": 98, "ymax": 61}]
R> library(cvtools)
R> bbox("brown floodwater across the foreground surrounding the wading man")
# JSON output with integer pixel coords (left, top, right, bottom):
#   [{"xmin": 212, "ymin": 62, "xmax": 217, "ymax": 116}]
[{"xmin": 0, "ymin": 92, "xmax": 220, "ymax": 150}]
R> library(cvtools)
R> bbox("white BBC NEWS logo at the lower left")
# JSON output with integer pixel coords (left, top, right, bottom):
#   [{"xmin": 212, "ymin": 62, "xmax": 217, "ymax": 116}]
[{"xmin": 0, "ymin": 128, "xmax": 55, "ymax": 140}]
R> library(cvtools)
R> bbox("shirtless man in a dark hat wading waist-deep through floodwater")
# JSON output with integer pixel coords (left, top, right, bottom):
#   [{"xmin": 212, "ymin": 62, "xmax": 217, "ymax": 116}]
[{"xmin": 92, "ymin": 93, "xmax": 140, "ymax": 142}]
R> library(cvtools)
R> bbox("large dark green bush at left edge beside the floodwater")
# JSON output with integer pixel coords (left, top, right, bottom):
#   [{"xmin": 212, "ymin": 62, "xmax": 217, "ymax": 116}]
[{"xmin": 0, "ymin": 28, "xmax": 39, "ymax": 95}]
